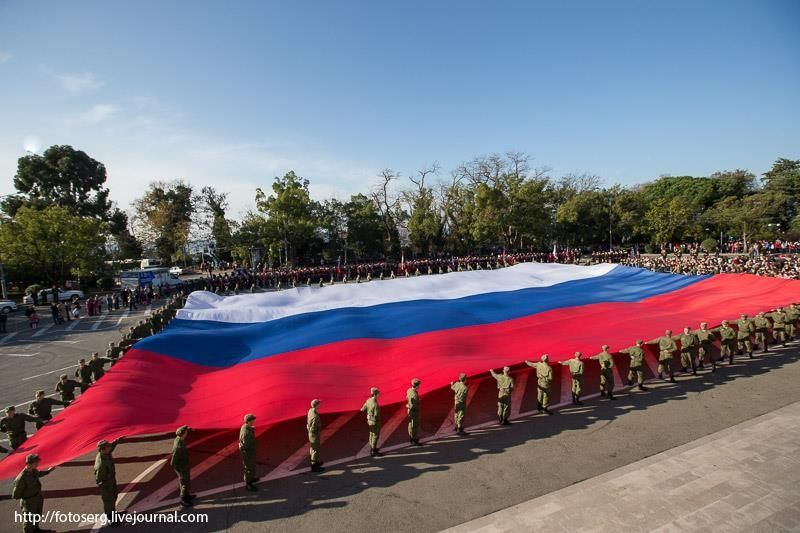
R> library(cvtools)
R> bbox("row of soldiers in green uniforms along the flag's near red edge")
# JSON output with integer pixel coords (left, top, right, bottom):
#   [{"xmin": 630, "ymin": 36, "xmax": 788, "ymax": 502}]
[{"xmin": 13, "ymin": 304, "xmax": 800, "ymax": 525}]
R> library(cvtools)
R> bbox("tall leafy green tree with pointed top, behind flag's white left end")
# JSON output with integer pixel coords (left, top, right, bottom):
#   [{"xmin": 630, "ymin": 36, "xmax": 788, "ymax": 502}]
[{"xmin": 256, "ymin": 171, "xmax": 319, "ymax": 265}]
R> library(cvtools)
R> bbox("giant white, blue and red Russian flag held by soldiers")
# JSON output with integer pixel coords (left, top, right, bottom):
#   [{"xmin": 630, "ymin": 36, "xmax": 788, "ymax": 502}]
[{"xmin": 0, "ymin": 263, "xmax": 800, "ymax": 478}]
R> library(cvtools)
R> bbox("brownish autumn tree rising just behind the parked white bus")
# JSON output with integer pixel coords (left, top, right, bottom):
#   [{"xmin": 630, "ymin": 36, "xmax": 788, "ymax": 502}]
[{"xmin": 133, "ymin": 180, "xmax": 194, "ymax": 263}]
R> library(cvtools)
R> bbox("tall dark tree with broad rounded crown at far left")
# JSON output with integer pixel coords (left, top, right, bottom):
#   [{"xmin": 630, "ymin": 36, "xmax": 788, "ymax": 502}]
[{"xmin": 0, "ymin": 145, "xmax": 111, "ymax": 220}]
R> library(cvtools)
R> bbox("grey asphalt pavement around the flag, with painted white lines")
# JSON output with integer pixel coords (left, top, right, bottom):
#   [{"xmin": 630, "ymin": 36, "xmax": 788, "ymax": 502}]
[{"xmin": 0, "ymin": 308, "xmax": 800, "ymax": 532}]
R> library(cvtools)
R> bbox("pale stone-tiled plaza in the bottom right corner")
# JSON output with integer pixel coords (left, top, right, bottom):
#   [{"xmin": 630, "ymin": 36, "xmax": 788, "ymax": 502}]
[{"xmin": 447, "ymin": 402, "xmax": 800, "ymax": 533}]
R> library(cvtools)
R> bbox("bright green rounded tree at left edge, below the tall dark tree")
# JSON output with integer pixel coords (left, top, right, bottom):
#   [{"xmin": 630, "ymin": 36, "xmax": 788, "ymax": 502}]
[{"xmin": 0, "ymin": 206, "xmax": 107, "ymax": 284}]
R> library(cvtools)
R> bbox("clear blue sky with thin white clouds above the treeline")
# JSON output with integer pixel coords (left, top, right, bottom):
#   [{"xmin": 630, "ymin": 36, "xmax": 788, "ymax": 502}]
[{"xmin": 0, "ymin": 0, "xmax": 800, "ymax": 215}]
